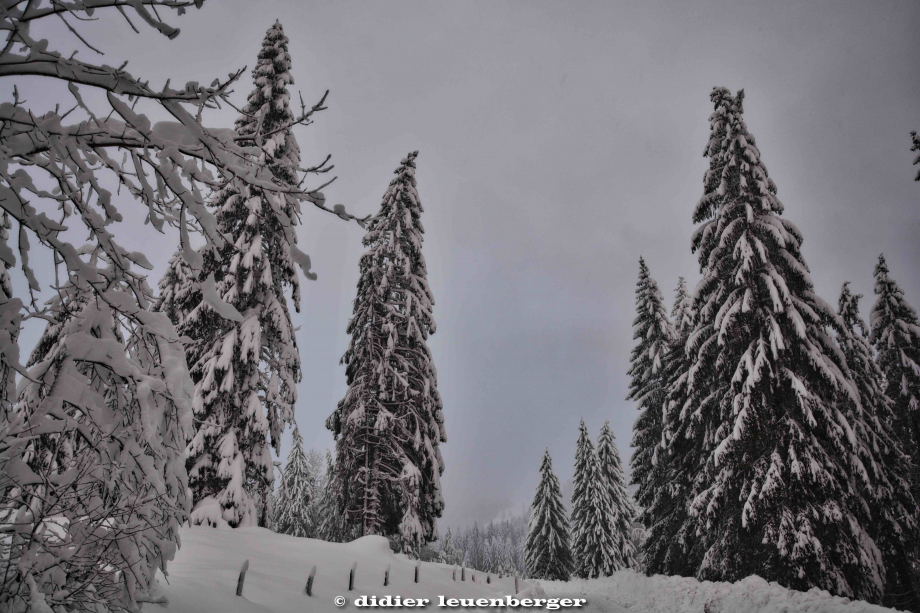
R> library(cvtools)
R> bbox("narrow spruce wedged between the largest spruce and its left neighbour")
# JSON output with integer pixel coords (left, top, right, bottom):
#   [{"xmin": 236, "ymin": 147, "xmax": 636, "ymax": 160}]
[{"xmin": 641, "ymin": 277, "xmax": 696, "ymax": 576}]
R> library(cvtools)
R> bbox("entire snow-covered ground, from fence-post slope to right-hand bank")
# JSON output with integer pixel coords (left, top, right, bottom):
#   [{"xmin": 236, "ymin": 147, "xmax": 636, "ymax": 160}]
[{"xmin": 155, "ymin": 527, "xmax": 904, "ymax": 613}]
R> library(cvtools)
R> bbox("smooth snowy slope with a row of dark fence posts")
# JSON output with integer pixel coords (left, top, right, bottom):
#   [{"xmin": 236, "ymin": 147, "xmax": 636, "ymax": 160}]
[{"xmin": 161, "ymin": 526, "xmax": 540, "ymax": 613}]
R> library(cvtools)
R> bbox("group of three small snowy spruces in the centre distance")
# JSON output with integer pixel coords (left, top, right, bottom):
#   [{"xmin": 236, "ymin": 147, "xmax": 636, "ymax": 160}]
[{"xmin": 524, "ymin": 420, "xmax": 636, "ymax": 581}]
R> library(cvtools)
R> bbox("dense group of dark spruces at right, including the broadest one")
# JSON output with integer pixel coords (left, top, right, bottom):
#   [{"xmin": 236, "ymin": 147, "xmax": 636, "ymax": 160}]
[{"xmin": 629, "ymin": 87, "xmax": 920, "ymax": 611}]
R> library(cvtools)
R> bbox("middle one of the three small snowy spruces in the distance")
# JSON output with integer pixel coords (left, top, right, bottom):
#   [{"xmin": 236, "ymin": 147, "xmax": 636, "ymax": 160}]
[{"xmin": 572, "ymin": 420, "xmax": 624, "ymax": 579}]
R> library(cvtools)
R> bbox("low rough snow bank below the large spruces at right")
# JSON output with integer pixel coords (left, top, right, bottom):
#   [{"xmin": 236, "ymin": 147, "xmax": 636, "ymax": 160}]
[{"xmin": 540, "ymin": 570, "xmax": 893, "ymax": 613}]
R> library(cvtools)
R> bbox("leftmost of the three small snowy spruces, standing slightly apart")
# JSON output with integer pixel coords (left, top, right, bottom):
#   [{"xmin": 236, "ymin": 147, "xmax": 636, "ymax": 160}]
[{"xmin": 524, "ymin": 449, "xmax": 574, "ymax": 581}]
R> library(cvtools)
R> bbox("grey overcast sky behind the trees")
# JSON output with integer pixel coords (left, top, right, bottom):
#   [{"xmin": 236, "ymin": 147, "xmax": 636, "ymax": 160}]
[{"xmin": 0, "ymin": 0, "xmax": 920, "ymax": 530}]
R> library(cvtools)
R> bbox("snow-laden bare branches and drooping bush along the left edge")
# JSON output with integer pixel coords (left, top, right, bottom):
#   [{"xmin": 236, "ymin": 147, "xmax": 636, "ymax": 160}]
[{"xmin": 0, "ymin": 0, "xmax": 365, "ymax": 610}]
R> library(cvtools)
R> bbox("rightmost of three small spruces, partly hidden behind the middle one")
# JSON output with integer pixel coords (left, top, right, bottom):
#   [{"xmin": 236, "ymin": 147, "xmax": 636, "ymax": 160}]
[{"xmin": 597, "ymin": 421, "xmax": 636, "ymax": 570}]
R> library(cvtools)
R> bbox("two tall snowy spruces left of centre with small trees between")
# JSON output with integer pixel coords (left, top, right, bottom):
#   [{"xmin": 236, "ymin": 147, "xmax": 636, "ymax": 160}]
[{"xmin": 154, "ymin": 22, "xmax": 446, "ymax": 553}]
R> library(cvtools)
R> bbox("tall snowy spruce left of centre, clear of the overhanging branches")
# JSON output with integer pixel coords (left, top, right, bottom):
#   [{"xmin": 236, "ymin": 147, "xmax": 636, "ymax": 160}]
[{"xmin": 326, "ymin": 151, "xmax": 447, "ymax": 551}]
